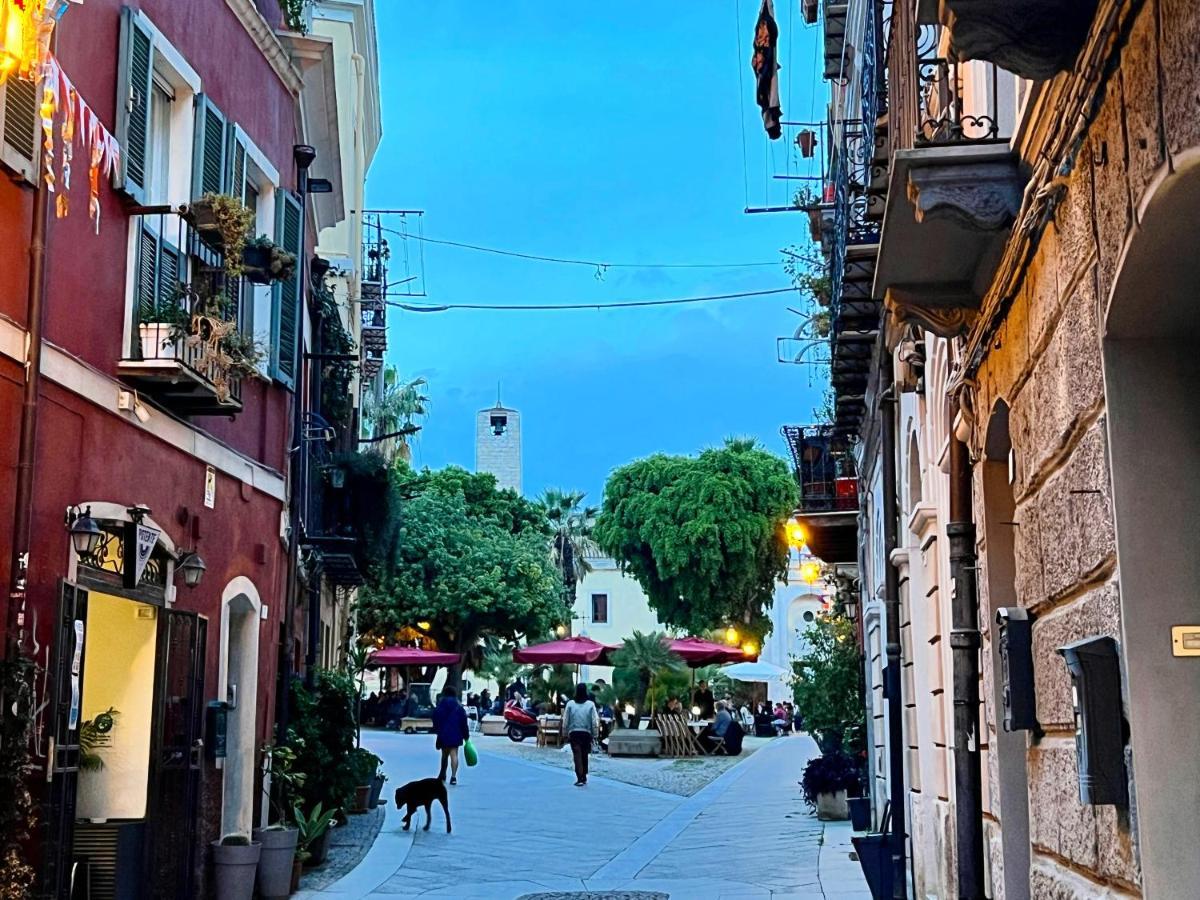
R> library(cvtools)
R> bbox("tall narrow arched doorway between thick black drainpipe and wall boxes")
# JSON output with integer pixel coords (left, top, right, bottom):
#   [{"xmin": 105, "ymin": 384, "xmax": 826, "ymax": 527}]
[{"xmin": 980, "ymin": 400, "xmax": 1030, "ymax": 900}]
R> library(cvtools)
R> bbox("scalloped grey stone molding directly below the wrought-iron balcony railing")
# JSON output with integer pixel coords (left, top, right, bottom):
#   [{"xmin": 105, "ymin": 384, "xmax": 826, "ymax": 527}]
[{"xmin": 908, "ymin": 161, "xmax": 1021, "ymax": 232}]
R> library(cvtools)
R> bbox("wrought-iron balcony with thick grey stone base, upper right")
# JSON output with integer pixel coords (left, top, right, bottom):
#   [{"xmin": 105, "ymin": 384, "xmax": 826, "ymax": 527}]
[{"xmin": 871, "ymin": 24, "xmax": 1024, "ymax": 337}]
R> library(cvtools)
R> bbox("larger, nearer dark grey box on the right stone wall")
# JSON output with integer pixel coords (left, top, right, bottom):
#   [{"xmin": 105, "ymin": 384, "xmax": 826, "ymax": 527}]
[{"xmin": 1058, "ymin": 637, "xmax": 1129, "ymax": 806}]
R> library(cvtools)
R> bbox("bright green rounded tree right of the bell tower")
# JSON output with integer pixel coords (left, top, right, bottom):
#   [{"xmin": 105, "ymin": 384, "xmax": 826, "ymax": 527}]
[{"xmin": 595, "ymin": 439, "xmax": 797, "ymax": 637}]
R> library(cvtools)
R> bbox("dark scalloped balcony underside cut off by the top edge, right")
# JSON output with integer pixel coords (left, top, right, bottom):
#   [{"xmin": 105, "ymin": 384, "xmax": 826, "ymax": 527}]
[{"xmin": 938, "ymin": 0, "xmax": 1097, "ymax": 82}]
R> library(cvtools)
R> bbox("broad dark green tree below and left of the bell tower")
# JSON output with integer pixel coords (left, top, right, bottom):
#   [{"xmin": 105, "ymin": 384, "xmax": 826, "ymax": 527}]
[{"xmin": 359, "ymin": 466, "xmax": 568, "ymax": 684}]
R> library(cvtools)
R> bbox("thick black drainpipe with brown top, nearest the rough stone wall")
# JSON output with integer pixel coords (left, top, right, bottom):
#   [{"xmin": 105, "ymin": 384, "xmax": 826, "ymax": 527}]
[{"xmin": 946, "ymin": 434, "xmax": 984, "ymax": 900}]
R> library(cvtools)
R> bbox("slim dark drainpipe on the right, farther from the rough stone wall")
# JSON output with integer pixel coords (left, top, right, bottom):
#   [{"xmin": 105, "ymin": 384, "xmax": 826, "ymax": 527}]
[{"xmin": 880, "ymin": 355, "xmax": 908, "ymax": 898}]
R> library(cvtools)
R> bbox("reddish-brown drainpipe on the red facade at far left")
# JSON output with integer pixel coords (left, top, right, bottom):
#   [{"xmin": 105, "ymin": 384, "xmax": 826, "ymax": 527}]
[{"xmin": 5, "ymin": 86, "xmax": 50, "ymax": 661}]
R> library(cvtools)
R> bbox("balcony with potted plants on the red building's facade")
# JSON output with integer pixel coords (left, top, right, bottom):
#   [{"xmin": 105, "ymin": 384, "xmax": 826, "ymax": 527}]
[{"xmin": 116, "ymin": 206, "xmax": 248, "ymax": 415}]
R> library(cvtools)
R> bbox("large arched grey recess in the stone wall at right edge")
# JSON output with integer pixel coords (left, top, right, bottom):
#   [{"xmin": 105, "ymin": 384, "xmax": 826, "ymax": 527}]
[{"xmin": 1098, "ymin": 148, "xmax": 1200, "ymax": 896}]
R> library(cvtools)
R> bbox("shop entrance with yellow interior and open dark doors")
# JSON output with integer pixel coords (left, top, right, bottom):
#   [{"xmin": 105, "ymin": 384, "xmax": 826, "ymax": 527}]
[{"xmin": 47, "ymin": 566, "xmax": 206, "ymax": 900}]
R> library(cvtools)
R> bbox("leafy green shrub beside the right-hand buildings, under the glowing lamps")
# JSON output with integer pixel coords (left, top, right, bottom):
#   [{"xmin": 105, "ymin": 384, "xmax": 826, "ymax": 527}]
[{"xmin": 792, "ymin": 614, "xmax": 865, "ymax": 752}]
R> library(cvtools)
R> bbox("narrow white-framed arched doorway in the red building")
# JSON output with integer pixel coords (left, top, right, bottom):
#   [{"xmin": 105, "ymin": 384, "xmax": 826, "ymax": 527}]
[{"xmin": 218, "ymin": 576, "xmax": 263, "ymax": 834}]
